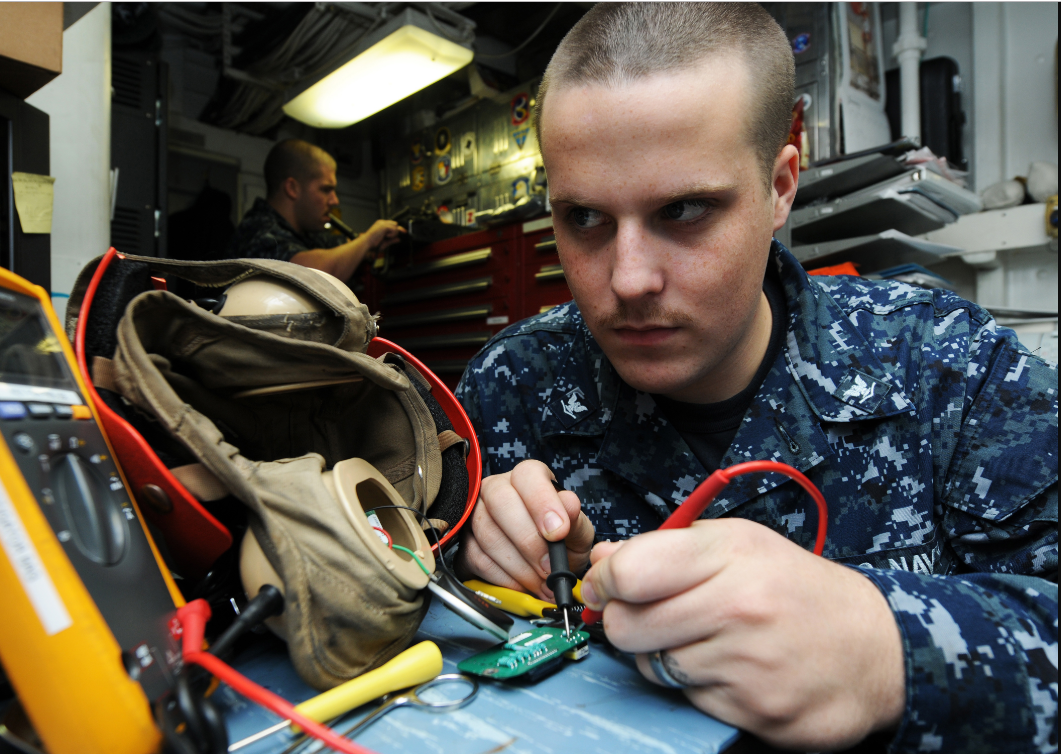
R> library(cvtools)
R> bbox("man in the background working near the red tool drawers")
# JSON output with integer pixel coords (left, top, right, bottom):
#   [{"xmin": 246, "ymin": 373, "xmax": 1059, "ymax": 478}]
[{"xmin": 227, "ymin": 139, "xmax": 403, "ymax": 281}]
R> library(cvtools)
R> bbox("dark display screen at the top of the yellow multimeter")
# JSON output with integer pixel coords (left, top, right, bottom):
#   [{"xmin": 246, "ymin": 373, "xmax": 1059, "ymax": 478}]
[{"xmin": 0, "ymin": 291, "xmax": 73, "ymax": 387}]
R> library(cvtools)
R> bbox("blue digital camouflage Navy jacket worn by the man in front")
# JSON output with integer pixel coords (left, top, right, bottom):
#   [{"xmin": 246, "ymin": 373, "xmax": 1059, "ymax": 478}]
[{"xmin": 457, "ymin": 242, "xmax": 1058, "ymax": 752}]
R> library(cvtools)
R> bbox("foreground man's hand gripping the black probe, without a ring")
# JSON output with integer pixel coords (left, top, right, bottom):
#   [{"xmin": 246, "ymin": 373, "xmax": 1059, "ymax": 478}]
[{"xmin": 457, "ymin": 460, "xmax": 593, "ymax": 600}]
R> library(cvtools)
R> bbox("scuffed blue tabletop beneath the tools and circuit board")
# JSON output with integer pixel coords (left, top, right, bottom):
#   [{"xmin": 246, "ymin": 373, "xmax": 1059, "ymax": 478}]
[{"xmin": 213, "ymin": 600, "xmax": 740, "ymax": 754}]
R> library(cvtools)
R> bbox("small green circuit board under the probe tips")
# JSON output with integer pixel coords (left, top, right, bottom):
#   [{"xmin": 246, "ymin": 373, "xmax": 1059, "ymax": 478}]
[{"xmin": 457, "ymin": 627, "xmax": 590, "ymax": 680}]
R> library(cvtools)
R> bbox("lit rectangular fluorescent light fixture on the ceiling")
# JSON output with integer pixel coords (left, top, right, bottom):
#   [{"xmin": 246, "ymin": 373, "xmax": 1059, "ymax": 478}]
[{"xmin": 283, "ymin": 8, "xmax": 474, "ymax": 128}]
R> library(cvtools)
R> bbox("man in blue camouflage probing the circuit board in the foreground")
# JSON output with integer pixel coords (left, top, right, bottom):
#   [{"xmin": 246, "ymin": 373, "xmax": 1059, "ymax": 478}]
[{"xmin": 458, "ymin": 3, "xmax": 1058, "ymax": 752}]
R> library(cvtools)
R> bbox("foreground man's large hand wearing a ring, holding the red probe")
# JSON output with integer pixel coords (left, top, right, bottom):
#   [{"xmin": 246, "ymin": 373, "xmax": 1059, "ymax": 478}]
[{"xmin": 582, "ymin": 519, "xmax": 906, "ymax": 751}]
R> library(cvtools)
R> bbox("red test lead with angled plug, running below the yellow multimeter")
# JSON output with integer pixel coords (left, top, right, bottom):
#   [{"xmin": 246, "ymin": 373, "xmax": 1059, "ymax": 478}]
[{"xmin": 177, "ymin": 599, "xmax": 384, "ymax": 754}]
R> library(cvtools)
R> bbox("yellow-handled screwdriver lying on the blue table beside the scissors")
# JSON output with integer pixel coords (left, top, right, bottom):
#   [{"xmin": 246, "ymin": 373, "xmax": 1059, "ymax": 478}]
[{"xmin": 228, "ymin": 642, "xmax": 442, "ymax": 752}]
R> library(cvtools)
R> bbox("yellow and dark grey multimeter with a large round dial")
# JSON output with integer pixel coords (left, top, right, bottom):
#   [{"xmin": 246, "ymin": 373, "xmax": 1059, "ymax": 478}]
[{"xmin": 0, "ymin": 269, "xmax": 184, "ymax": 754}]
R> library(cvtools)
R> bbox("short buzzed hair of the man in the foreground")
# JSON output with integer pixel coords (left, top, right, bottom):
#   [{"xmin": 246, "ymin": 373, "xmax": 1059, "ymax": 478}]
[{"xmin": 535, "ymin": 2, "xmax": 796, "ymax": 183}]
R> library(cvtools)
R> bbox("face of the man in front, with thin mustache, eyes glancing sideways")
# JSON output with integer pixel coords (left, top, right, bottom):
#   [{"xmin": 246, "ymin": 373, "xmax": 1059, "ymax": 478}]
[{"xmin": 541, "ymin": 57, "xmax": 790, "ymax": 403}]
